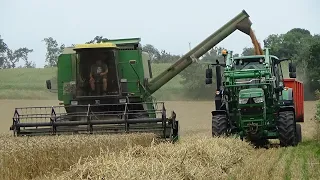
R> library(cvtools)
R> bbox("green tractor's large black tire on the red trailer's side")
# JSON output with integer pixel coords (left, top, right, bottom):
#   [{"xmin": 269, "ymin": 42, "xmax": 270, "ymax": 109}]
[{"xmin": 277, "ymin": 111, "xmax": 297, "ymax": 147}]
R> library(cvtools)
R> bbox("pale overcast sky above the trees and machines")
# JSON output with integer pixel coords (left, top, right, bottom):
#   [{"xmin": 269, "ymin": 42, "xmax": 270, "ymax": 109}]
[{"xmin": 0, "ymin": 0, "xmax": 320, "ymax": 67}]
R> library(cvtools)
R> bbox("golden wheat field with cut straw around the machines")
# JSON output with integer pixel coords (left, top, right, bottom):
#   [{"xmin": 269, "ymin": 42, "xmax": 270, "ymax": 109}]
[{"xmin": 0, "ymin": 100, "xmax": 320, "ymax": 180}]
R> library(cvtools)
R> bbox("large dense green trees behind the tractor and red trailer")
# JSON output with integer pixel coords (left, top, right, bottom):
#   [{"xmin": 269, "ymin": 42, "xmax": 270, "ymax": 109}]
[{"xmin": 264, "ymin": 28, "xmax": 319, "ymax": 99}]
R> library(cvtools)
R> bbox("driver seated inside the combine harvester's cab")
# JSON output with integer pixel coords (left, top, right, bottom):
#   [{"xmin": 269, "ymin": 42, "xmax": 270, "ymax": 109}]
[{"xmin": 90, "ymin": 59, "xmax": 108, "ymax": 95}]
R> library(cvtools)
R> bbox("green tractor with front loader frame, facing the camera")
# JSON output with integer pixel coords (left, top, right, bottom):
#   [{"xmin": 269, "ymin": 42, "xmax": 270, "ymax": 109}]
[{"xmin": 206, "ymin": 48, "xmax": 303, "ymax": 146}]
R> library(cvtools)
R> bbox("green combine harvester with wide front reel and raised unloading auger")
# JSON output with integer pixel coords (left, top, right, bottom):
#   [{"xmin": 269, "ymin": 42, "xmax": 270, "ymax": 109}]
[{"xmin": 10, "ymin": 10, "xmax": 268, "ymax": 141}]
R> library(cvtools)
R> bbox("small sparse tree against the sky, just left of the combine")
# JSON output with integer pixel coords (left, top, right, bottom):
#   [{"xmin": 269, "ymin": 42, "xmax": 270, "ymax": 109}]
[{"xmin": 43, "ymin": 37, "xmax": 65, "ymax": 67}]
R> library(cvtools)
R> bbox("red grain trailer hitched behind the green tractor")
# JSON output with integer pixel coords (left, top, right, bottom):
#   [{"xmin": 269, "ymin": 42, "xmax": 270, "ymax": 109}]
[{"xmin": 284, "ymin": 78, "xmax": 304, "ymax": 122}]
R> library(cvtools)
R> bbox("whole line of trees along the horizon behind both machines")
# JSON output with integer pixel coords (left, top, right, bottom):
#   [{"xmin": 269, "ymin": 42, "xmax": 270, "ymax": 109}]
[{"xmin": 0, "ymin": 28, "xmax": 320, "ymax": 98}]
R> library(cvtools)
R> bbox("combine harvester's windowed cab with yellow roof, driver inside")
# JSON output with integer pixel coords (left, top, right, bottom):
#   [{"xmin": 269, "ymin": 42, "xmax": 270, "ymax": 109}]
[{"xmin": 74, "ymin": 43, "xmax": 120, "ymax": 97}]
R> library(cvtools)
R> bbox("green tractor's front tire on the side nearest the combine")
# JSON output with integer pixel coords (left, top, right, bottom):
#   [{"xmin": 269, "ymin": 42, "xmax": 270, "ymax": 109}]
[{"xmin": 212, "ymin": 114, "xmax": 229, "ymax": 137}]
